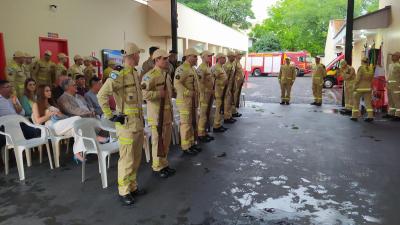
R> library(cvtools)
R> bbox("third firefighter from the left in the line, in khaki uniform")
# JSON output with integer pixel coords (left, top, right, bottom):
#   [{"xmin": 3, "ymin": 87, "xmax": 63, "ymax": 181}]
[{"xmin": 174, "ymin": 48, "xmax": 201, "ymax": 155}]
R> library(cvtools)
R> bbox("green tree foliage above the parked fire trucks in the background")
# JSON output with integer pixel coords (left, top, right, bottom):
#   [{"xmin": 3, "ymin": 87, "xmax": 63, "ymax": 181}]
[{"xmin": 250, "ymin": 0, "xmax": 378, "ymax": 55}]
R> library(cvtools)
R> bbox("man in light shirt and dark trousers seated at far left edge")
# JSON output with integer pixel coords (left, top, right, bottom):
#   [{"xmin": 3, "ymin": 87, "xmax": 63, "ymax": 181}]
[{"xmin": 0, "ymin": 80, "xmax": 40, "ymax": 149}]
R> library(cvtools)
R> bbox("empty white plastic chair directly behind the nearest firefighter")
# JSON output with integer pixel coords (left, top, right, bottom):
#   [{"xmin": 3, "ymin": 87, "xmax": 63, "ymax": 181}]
[{"xmin": 74, "ymin": 118, "xmax": 119, "ymax": 188}]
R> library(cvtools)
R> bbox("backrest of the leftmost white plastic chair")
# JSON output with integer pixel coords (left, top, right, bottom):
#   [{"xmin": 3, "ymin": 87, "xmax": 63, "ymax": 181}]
[{"xmin": 0, "ymin": 115, "xmax": 31, "ymax": 144}]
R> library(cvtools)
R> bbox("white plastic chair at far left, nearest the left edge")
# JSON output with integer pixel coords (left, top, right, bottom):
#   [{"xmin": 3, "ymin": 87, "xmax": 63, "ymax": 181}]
[{"xmin": 0, "ymin": 115, "xmax": 53, "ymax": 180}]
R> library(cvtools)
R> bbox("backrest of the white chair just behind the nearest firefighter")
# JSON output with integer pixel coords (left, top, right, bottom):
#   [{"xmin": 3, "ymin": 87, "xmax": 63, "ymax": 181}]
[{"xmin": 73, "ymin": 118, "xmax": 100, "ymax": 150}]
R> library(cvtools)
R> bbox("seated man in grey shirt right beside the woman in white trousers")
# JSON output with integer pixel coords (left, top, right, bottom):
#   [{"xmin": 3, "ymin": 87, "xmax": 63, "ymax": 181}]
[{"xmin": 57, "ymin": 78, "xmax": 94, "ymax": 117}]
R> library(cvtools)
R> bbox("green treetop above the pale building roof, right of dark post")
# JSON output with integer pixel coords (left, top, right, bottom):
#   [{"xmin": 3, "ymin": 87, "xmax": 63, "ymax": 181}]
[{"xmin": 178, "ymin": 0, "xmax": 254, "ymax": 30}]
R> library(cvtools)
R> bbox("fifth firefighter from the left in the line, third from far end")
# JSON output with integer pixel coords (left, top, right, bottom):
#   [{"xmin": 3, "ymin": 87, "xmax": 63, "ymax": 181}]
[{"xmin": 211, "ymin": 53, "xmax": 228, "ymax": 133}]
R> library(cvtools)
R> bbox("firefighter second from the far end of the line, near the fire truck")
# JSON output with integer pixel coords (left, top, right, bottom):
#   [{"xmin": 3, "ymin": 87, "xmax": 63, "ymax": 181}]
[{"xmin": 223, "ymin": 51, "xmax": 236, "ymax": 123}]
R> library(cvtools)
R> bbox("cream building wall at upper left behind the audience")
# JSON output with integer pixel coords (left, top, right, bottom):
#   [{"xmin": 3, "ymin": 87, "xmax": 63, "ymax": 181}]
[{"xmin": 0, "ymin": 0, "xmax": 167, "ymax": 64}]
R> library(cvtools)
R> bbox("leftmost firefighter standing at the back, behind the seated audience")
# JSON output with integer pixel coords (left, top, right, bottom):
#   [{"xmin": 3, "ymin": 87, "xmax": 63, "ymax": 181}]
[{"xmin": 6, "ymin": 51, "xmax": 27, "ymax": 98}]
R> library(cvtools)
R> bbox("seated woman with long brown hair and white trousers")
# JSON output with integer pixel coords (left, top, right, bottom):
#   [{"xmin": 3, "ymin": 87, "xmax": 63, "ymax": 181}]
[{"xmin": 32, "ymin": 85, "xmax": 83, "ymax": 163}]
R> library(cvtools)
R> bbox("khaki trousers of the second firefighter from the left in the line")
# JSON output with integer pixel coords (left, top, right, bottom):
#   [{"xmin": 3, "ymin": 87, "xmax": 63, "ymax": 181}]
[{"xmin": 151, "ymin": 123, "xmax": 172, "ymax": 171}]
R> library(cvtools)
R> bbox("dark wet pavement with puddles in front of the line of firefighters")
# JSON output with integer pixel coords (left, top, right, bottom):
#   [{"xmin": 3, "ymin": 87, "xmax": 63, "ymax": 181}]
[{"xmin": 0, "ymin": 81, "xmax": 400, "ymax": 225}]
